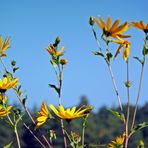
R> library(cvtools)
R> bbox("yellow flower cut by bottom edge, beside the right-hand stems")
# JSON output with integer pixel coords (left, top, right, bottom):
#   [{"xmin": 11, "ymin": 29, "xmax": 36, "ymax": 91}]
[{"xmin": 107, "ymin": 133, "xmax": 125, "ymax": 148}]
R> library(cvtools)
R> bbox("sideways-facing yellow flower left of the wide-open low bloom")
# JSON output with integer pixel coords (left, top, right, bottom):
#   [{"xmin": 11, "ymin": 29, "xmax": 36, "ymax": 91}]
[{"xmin": 36, "ymin": 102, "xmax": 50, "ymax": 128}]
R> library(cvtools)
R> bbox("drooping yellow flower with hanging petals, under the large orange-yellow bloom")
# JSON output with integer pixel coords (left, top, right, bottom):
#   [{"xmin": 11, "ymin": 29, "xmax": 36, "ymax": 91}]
[{"xmin": 113, "ymin": 37, "xmax": 130, "ymax": 61}]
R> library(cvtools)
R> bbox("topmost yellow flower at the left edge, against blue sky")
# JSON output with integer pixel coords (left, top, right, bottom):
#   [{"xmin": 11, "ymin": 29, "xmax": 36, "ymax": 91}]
[{"xmin": 0, "ymin": 36, "xmax": 10, "ymax": 57}]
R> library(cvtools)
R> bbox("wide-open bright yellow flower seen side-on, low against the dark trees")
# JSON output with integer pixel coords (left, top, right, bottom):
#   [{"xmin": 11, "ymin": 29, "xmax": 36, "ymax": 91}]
[{"xmin": 50, "ymin": 104, "xmax": 92, "ymax": 120}]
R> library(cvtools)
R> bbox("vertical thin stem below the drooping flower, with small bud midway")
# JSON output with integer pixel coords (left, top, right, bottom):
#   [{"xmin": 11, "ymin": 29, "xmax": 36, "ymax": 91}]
[{"xmin": 125, "ymin": 60, "xmax": 130, "ymax": 148}]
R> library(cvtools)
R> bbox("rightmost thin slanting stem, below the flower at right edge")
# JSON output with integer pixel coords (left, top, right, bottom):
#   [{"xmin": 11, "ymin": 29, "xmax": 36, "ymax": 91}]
[{"xmin": 131, "ymin": 57, "xmax": 145, "ymax": 129}]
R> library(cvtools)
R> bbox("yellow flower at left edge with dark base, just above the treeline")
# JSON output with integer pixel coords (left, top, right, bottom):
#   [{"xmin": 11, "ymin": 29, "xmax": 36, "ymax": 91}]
[{"xmin": 0, "ymin": 77, "xmax": 18, "ymax": 92}]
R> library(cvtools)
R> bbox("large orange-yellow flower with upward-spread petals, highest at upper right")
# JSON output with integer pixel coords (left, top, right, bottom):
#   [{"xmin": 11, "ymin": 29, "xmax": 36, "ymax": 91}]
[{"xmin": 94, "ymin": 17, "xmax": 130, "ymax": 38}]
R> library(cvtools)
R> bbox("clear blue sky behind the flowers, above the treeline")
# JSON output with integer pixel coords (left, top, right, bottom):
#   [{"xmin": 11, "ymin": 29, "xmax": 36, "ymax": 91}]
[{"xmin": 0, "ymin": 0, "xmax": 148, "ymax": 109}]
